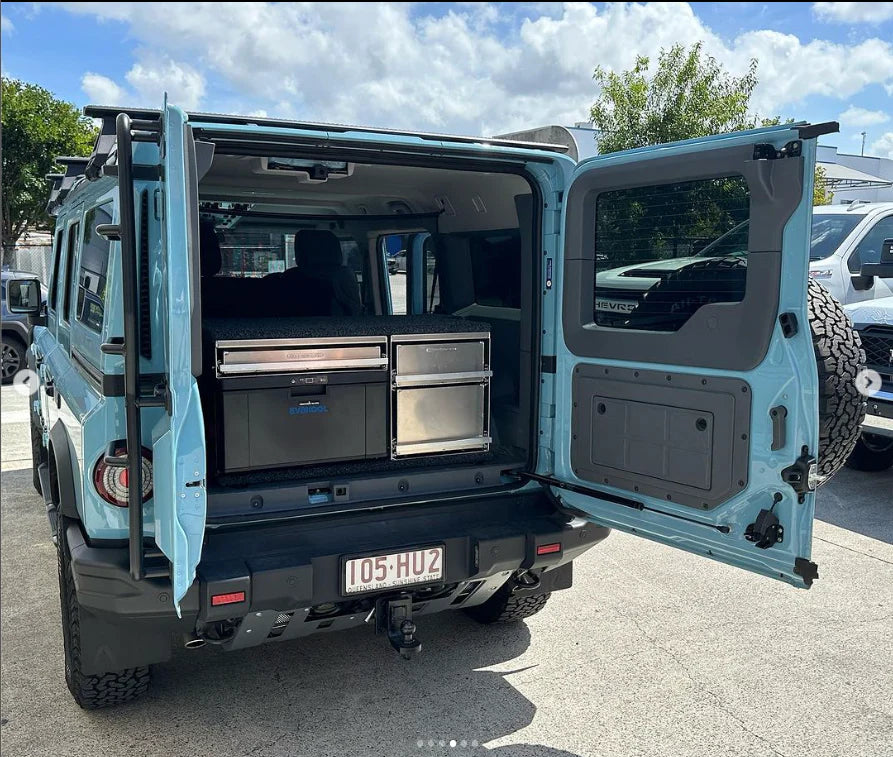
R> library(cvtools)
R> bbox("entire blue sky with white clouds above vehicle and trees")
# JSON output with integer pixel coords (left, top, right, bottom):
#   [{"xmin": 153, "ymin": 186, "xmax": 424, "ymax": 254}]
[{"xmin": 0, "ymin": 2, "xmax": 893, "ymax": 157}]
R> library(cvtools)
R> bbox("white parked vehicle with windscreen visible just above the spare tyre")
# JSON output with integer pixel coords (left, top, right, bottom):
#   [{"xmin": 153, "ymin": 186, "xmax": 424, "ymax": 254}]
[{"xmin": 809, "ymin": 202, "xmax": 893, "ymax": 305}]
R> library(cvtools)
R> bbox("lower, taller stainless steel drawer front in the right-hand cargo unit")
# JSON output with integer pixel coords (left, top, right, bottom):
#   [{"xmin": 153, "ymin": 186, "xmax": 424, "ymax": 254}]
[{"xmin": 394, "ymin": 384, "xmax": 490, "ymax": 455}]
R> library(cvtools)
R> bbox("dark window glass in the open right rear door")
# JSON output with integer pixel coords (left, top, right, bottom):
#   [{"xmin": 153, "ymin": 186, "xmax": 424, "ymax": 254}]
[{"xmin": 596, "ymin": 176, "xmax": 750, "ymax": 331}]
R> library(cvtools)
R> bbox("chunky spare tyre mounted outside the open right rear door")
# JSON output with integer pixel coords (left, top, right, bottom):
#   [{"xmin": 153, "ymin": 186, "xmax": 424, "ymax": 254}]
[{"xmin": 808, "ymin": 279, "xmax": 865, "ymax": 482}]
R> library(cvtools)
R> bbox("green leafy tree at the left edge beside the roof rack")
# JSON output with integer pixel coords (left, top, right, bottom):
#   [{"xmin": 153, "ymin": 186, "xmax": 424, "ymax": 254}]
[{"xmin": 0, "ymin": 77, "xmax": 96, "ymax": 263}]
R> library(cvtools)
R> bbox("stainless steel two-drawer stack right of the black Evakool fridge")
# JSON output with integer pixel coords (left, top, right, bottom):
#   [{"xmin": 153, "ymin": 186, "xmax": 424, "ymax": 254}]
[{"xmin": 391, "ymin": 333, "xmax": 493, "ymax": 458}]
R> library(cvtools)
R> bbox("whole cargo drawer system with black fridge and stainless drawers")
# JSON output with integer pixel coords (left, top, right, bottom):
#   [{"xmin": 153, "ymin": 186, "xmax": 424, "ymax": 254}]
[{"xmin": 206, "ymin": 316, "xmax": 492, "ymax": 473}]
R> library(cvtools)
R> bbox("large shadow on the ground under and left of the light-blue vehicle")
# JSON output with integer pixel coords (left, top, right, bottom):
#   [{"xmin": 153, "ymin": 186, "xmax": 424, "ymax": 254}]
[{"xmin": 0, "ymin": 469, "xmax": 578, "ymax": 757}]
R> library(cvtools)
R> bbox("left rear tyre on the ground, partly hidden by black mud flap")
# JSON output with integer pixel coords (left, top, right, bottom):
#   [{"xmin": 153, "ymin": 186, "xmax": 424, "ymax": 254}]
[{"xmin": 57, "ymin": 516, "xmax": 151, "ymax": 710}]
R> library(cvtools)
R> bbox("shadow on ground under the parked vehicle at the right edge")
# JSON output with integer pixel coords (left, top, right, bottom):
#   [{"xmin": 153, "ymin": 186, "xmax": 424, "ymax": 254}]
[{"xmin": 815, "ymin": 468, "xmax": 893, "ymax": 544}]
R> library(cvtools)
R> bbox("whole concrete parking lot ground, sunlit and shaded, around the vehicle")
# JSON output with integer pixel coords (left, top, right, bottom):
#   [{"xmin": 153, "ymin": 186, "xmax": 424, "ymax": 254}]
[{"xmin": 0, "ymin": 387, "xmax": 893, "ymax": 757}]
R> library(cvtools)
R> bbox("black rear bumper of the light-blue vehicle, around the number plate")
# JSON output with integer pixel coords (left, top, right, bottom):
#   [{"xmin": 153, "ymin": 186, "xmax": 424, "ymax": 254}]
[{"xmin": 68, "ymin": 492, "xmax": 609, "ymax": 672}]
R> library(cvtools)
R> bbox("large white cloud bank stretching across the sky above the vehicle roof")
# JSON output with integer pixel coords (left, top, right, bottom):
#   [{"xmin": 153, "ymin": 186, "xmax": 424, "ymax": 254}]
[{"xmin": 55, "ymin": 3, "xmax": 893, "ymax": 134}]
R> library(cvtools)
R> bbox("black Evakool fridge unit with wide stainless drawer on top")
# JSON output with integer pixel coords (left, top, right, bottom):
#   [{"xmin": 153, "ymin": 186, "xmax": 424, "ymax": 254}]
[{"xmin": 214, "ymin": 336, "xmax": 389, "ymax": 473}]
